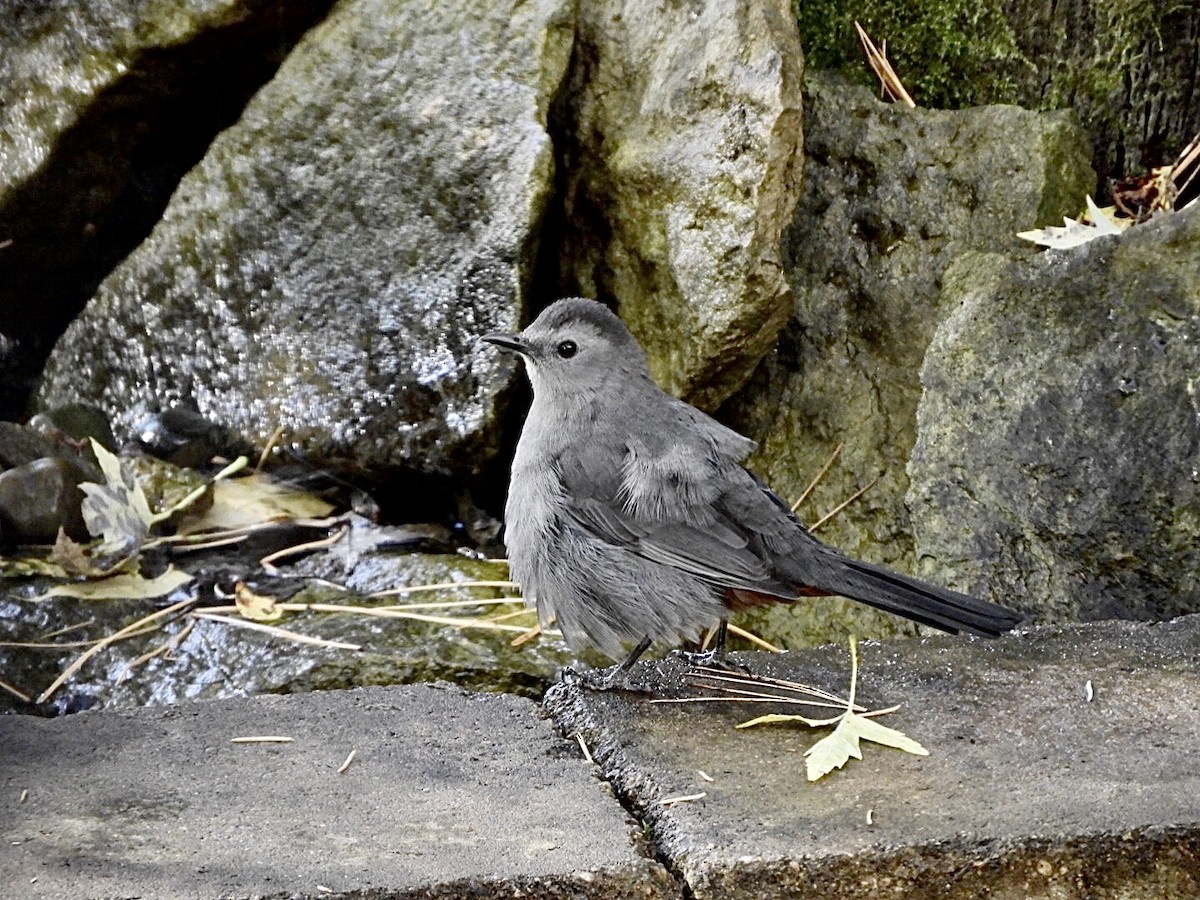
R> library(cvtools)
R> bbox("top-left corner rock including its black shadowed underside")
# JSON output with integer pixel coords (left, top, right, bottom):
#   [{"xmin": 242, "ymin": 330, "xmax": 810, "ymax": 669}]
[{"xmin": 0, "ymin": 0, "xmax": 332, "ymax": 416}]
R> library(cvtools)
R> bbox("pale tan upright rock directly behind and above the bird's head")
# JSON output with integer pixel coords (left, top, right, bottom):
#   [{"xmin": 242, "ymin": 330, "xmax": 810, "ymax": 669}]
[{"xmin": 560, "ymin": 0, "xmax": 802, "ymax": 407}]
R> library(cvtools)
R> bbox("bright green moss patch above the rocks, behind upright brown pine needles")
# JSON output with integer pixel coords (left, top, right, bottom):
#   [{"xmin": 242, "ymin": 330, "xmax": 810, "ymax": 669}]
[{"xmin": 794, "ymin": 0, "xmax": 1030, "ymax": 109}]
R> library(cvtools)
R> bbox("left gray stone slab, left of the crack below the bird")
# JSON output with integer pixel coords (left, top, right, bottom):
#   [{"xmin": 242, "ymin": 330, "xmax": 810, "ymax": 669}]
[{"xmin": 0, "ymin": 685, "xmax": 678, "ymax": 900}]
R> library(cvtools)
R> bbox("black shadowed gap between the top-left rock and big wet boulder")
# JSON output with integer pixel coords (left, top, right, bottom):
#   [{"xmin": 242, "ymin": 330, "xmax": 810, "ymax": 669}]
[{"xmin": 0, "ymin": 0, "xmax": 332, "ymax": 419}]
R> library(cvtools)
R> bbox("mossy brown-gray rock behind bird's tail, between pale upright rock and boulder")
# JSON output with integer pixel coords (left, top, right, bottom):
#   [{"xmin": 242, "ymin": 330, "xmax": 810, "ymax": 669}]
[{"xmin": 724, "ymin": 73, "xmax": 1092, "ymax": 646}]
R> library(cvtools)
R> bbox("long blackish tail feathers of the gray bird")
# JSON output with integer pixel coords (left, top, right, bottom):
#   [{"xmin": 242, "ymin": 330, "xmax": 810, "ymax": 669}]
[{"xmin": 806, "ymin": 554, "xmax": 1025, "ymax": 637}]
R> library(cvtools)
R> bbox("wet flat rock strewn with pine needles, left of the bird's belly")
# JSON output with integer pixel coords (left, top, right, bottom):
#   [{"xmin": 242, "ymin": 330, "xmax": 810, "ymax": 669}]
[{"xmin": 0, "ymin": 518, "xmax": 580, "ymax": 715}]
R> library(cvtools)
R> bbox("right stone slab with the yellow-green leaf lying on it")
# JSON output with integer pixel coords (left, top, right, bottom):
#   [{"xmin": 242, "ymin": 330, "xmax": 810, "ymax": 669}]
[{"xmin": 546, "ymin": 617, "xmax": 1200, "ymax": 899}]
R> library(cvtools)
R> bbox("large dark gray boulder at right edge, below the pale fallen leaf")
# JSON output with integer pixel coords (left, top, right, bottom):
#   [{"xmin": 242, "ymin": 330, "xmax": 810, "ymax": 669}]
[{"xmin": 908, "ymin": 210, "xmax": 1200, "ymax": 620}]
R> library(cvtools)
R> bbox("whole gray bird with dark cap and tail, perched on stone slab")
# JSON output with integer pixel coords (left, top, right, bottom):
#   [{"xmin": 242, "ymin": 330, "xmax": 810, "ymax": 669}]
[{"xmin": 482, "ymin": 298, "xmax": 1021, "ymax": 686}]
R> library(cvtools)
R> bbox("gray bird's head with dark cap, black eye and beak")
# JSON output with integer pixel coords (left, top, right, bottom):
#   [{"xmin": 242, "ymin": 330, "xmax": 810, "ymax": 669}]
[{"xmin": 480, "ymin": 296, "xmax": 648, "ymax": 392}]
